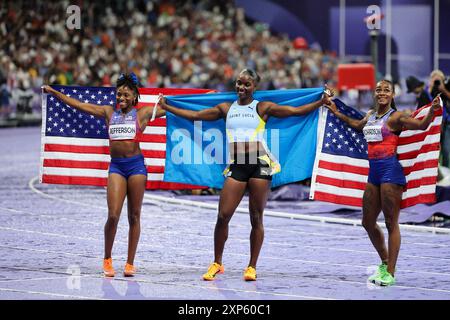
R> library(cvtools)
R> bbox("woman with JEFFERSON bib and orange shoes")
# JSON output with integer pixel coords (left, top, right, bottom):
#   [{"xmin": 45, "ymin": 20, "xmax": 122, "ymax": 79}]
[{"xmin": 43, "ymin": 73, "xmax": 165, "ymax": 277}]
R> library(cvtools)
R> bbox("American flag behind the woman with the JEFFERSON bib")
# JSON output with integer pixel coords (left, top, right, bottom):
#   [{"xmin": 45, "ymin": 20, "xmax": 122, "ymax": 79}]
[{"xmin": 40, "ymin": 86, "xmax": 210, "ymax": 189}]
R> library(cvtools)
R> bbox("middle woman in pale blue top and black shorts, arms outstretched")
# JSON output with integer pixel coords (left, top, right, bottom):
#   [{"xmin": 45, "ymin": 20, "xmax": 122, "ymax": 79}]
[{"xmin": 160, "ymin": 69, "xmax": 330, "ymax": 281}]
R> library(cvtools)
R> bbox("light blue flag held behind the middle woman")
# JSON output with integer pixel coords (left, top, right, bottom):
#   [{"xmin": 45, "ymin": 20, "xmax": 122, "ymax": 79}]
[{"xmin": 164, "ymin": 88, "xmax": 323, "ymax": 189}]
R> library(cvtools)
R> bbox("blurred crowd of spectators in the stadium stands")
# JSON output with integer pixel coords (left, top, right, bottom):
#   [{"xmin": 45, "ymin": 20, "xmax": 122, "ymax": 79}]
[{"xmin": 0, "ymin": 0, "xmax": 338, "ymax": 117}]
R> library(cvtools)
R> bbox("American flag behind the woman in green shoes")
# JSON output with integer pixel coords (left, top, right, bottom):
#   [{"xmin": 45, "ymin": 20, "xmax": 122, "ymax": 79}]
[{"xmin": 310, "ymin": 99, "xmax": 442, "ymax": 208}]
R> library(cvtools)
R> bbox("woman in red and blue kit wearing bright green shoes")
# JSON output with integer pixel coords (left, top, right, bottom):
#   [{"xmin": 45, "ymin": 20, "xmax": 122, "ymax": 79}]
[{"xmin": 327, "ymin": 80, "xmax": 440, "ymax": 286}]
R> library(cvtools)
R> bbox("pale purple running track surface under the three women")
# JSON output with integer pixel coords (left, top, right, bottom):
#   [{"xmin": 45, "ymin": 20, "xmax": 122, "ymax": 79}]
[{"xmin": 0, "ymin": 128, "xmax": 450, "ymax": 300}]
